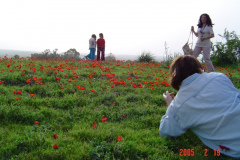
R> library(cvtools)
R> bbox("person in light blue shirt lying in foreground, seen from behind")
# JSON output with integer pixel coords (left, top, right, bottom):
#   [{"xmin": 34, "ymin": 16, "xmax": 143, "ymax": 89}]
[{"xmin": 159, "ymin": 56, "xmax": 240, "ymax": 158}]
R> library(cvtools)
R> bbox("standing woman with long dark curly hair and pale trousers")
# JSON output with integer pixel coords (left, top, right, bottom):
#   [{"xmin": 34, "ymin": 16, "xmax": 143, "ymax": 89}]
[{"xmin": 191, "ymin": 13, "xmax": 214, "ymax": 72}]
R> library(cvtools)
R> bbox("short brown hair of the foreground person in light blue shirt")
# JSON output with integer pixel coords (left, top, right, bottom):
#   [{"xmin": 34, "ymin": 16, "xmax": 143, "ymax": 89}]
[{"xmin": 170, "ymin": 56, "xmax": 203, "ymax": 90}]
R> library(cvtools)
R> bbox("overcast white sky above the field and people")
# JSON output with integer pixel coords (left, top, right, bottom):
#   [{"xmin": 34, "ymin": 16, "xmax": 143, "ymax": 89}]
[{"xmin": 0, "ymin": 0, "xmax": 240, "ymax": 55}]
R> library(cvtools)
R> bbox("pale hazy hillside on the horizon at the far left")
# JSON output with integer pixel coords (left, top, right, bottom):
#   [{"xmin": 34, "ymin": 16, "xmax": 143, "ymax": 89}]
[{"xmin": 0, "ymin": 49, "xmax": 37, "ymax": 57}]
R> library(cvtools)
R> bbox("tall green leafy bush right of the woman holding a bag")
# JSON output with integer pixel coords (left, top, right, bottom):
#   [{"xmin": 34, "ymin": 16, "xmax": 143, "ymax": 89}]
[{"xmin": 211, "ymin": 29, "xmax": 240, "ymax": 65}]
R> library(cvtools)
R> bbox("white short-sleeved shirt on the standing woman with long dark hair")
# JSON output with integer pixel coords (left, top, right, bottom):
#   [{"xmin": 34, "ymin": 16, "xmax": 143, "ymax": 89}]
[{"xmin": 196, "ymin": 25, "xmax": 214, "ymax": 47}]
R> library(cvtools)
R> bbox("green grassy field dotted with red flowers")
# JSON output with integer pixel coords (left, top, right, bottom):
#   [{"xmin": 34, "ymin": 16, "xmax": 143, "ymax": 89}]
[{"xmin": 0, "ymin": 58, "xmax": 240, "ymax": 160}]
